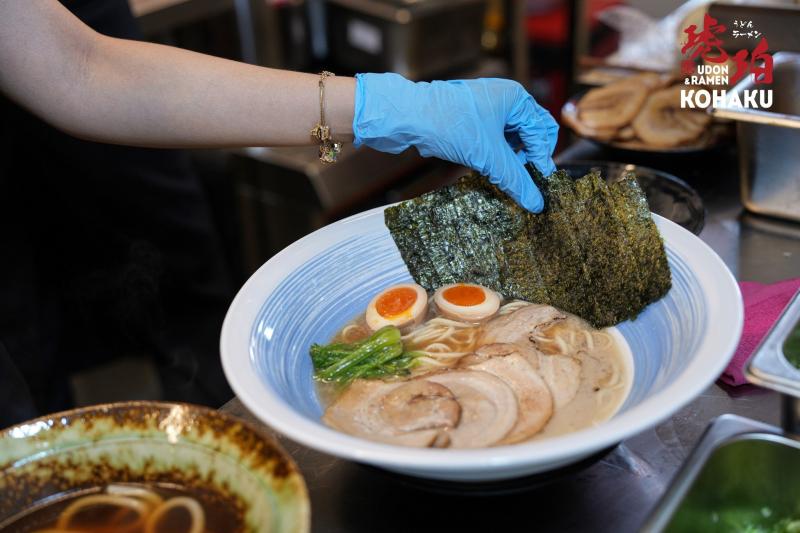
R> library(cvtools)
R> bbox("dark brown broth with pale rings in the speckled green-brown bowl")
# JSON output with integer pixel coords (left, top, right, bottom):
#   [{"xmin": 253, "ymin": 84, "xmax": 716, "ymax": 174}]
[{"xmin": 3, "ymin": 483, "xmax": 244, "ymax": 533}]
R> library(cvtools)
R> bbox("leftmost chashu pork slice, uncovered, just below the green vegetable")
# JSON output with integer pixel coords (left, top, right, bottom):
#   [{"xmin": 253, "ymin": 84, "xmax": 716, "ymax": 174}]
[{"xmin": 322, "ymin": 379, "xmax": 461, "ymax": 447}]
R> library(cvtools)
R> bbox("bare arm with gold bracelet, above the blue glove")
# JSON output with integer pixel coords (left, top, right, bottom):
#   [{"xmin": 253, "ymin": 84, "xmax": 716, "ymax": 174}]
[{"xmin": 0, "ymin": 0, "xmax": 355, "ymax": 147}]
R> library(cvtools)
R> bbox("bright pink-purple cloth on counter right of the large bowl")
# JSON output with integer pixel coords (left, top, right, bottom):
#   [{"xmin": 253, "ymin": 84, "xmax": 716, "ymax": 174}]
[{"xmin": 719, "ymin": 278, "xmax": 800, "ymax": 386}]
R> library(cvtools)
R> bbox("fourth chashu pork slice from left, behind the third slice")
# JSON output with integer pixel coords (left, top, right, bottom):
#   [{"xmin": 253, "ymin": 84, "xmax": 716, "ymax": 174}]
[{"xmin": 476, "ymin": 343, "xmax": 582, "ymax": 409}]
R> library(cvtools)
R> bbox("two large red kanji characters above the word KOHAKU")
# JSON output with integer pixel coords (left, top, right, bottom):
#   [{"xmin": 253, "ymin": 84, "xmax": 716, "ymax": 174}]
[{"xmin": 681, "ymin": 13, "xmax": 772, "ymax": 85}]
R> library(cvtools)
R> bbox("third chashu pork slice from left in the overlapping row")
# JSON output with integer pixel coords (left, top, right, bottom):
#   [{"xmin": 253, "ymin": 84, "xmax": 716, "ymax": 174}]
[{"xmin": 469, "ymin": 352, "xmax": 553, "ymax": 444}]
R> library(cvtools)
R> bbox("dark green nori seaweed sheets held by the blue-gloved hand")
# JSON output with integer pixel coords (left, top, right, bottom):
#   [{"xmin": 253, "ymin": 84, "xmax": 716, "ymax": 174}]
[{"xmin": 385, "ymin": 166, "xmax": 671, "ymax": 327}]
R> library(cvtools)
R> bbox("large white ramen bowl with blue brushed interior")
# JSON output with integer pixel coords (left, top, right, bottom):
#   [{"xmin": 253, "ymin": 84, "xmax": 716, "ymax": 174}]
[{"xmin": 220, "ymin": 208, "xmax": 743, "ymax": 481}]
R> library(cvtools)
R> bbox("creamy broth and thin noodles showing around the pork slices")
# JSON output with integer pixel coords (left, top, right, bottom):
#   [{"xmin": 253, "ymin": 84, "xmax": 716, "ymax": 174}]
[{"xmin": 317, "ymin": 300, "xmax": 633, "ymax": 440}]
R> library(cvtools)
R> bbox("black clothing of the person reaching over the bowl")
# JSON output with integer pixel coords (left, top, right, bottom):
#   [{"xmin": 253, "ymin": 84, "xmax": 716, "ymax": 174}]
[{"xmin": 0, "ymin": 0, "xmax": 232, "ymax": 427}]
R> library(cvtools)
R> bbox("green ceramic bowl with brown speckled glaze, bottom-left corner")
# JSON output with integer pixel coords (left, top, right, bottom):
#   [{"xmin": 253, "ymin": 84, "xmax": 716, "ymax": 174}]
[{"xmin": 0, "ymin": 402, "xmax": 310, "ymax": 533}]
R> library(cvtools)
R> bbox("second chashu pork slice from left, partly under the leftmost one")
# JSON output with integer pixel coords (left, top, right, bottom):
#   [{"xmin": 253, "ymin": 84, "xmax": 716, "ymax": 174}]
[{"xmin": 425, "ymin": 369, "xmax": 519, "ymax": 448}]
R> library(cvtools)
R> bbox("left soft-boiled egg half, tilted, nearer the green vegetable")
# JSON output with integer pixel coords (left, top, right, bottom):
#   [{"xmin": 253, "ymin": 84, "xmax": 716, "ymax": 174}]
[{"xmin": 366, "ymin": 283, "xmax": 428, "ymax": 331}]
